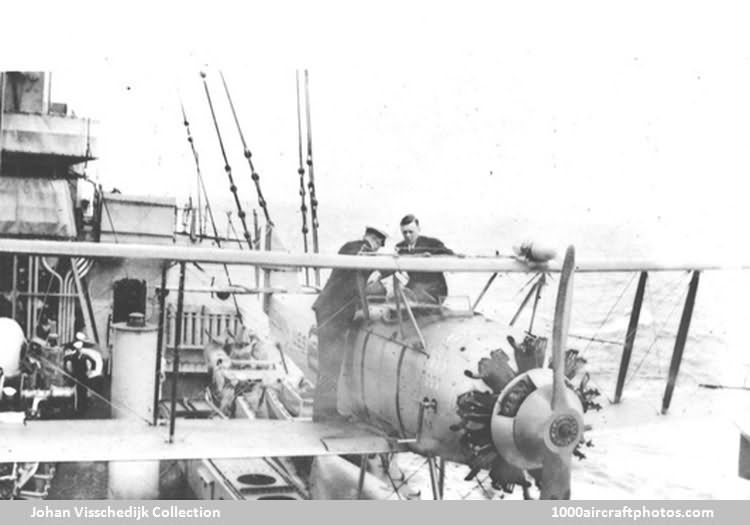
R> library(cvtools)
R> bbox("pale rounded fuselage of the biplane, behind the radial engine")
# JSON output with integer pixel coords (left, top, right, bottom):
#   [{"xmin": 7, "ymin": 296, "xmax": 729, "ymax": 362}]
[{"xmin": 269, "ymin": 298, "xmax": 515, "ymax": 461}]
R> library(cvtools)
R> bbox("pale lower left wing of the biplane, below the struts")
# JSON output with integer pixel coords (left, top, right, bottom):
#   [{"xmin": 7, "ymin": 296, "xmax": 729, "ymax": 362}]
[{"xmin": 0, "ymin": 419, "xmax": 403, "ymax": 463}]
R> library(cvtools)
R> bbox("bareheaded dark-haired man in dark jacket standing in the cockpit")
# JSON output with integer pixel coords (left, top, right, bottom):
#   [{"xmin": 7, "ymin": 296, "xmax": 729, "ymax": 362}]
[{"xmin": 396, "ymin": 214, "xmax": 453, "ymax": 303}]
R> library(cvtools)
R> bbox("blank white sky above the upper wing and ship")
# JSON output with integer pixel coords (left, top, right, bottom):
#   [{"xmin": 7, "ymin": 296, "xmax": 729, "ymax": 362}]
[{"xmin": 2, "ymin": 1, "xmax": 750, "ymax": 256}]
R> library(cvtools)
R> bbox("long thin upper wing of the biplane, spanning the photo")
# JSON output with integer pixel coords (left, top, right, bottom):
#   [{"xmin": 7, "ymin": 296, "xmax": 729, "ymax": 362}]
[{"xmin": 0, "ymin": 239, "xmax": 750, "ymax": 272}]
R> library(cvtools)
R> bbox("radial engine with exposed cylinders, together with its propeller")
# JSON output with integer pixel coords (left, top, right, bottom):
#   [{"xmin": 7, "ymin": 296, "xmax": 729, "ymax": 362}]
[{"xmin": 451, "ymin": 246, "xmax": 597, "ymax": 499}]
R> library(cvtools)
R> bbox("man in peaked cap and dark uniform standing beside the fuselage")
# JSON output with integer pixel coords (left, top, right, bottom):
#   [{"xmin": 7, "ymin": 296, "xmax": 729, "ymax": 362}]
[{"xmin": 312, "ymin": 226, "xmax": 386, "ymax": 421}]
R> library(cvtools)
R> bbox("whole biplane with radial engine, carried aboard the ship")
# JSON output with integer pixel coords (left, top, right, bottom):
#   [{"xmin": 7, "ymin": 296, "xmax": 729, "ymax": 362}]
[{"xmin": 0, "ymin": 239, "xmax": 748, "ymax": 499}]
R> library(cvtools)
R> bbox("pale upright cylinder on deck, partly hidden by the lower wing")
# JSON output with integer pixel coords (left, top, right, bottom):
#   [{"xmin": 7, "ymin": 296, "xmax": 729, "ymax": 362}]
[{"xmin": 109, "ymin": 314, "xmax": 159, "ymax": 499}]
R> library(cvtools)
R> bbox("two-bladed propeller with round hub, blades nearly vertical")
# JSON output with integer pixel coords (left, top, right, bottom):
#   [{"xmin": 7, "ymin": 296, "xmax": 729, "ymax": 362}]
[{"xmin": 541, "ymin": 246, "xmax": 583, "ymax": 499}]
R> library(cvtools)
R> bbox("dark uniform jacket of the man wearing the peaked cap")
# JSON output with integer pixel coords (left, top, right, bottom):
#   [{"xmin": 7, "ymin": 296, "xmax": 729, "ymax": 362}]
[{"xmin": 312, "ymin": 239, "xmax": 373, "ymax": 324}]
